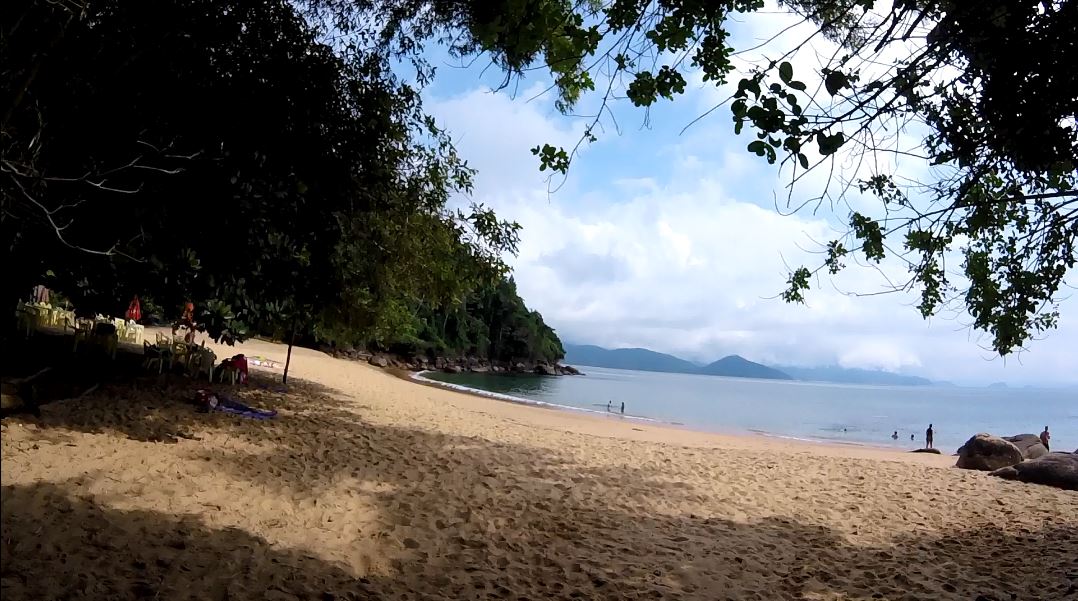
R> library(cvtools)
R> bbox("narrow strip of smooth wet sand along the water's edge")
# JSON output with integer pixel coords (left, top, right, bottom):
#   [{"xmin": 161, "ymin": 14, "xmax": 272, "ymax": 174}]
[{"xmin": 396, "ymin": 367, "xmax": 954, "ymax": 467}]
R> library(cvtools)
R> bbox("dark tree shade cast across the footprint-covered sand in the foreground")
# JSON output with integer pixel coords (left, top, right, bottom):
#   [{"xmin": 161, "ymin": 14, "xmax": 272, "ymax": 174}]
[{"xmin": 0, "ymin": 336, "xmax": 1078, "ymax": 601}]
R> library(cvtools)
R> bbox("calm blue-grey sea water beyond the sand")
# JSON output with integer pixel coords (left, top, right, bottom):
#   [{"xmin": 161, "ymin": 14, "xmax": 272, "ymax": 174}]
[{"xmin": 421, "ymin": 366, "xmax": 1078, "ymax": 453}]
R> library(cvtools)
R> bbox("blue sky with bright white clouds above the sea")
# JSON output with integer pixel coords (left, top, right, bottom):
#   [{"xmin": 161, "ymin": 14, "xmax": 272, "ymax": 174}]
[{"xmin": 407, "ymin": 2, "xmax": 1078, "ymax": 385}]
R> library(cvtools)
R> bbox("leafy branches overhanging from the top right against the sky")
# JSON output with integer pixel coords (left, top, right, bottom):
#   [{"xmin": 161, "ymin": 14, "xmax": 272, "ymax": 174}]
[{"xmin": 323, "ymin": 0, "xmax": 1078, "ymax": 354}]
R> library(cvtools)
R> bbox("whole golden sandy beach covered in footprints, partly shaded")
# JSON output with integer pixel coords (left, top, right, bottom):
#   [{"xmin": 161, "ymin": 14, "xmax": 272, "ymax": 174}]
[{"xmin": 0, "ymin": 333, "xmax": 1078, "ymax": 601}]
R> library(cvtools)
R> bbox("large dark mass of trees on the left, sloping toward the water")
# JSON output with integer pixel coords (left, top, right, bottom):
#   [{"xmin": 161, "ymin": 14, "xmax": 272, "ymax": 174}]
[{"xmin": 0, "ymin": 0, "xmax": 562, "ymax": 361}]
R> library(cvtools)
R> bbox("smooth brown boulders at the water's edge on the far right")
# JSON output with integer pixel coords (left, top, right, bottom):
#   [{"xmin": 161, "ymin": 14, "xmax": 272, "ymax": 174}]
[{"xmin": 956, "ymin": 433, "xmax": 1078, "ymax": 490}]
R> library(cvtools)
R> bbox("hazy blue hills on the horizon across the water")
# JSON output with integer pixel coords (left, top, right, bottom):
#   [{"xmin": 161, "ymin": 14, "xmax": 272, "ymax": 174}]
[{"xmin": 565, "ymin": 345, "xmax": 932, "ymax": 386}]
